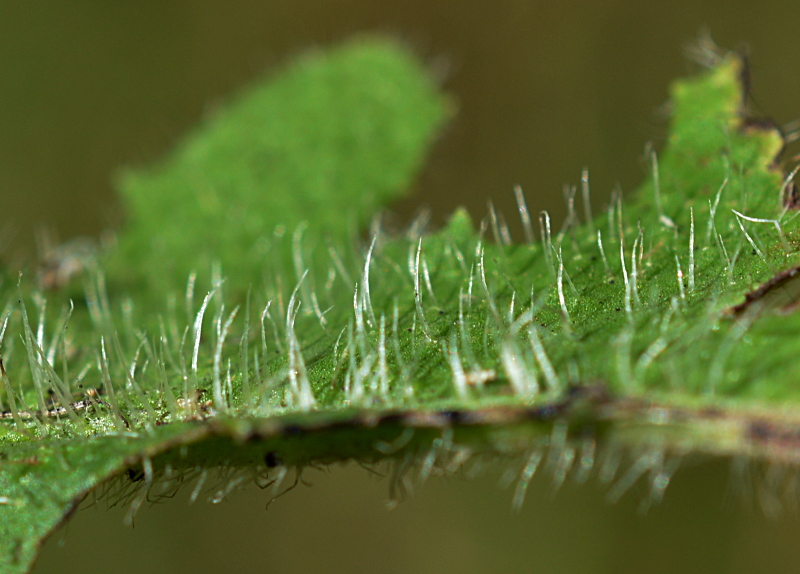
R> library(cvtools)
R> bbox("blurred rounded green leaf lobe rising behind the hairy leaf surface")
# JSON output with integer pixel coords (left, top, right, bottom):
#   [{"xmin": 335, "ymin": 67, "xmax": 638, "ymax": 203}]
[{"xmin": 112, "ymin": 38, "xmax": 451, "ymax": 292}]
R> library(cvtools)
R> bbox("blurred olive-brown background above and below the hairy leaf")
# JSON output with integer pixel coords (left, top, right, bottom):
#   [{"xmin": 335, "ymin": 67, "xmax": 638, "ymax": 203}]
[{"xmin": 0, "ymin": 0, "xmax": 800, "ymax": 574}]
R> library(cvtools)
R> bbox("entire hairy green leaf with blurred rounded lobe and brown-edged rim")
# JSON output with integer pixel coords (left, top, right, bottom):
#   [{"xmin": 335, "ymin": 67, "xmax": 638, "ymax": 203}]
[{"xmin": 0, "ymin": 38, "xmax": 800, "ymax": 571}]
